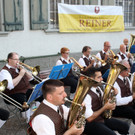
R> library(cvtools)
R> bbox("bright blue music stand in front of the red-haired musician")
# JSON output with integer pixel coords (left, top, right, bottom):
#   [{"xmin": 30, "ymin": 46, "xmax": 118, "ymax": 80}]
[{"xmin": 49, "ymin": 63, "xmax": 73, "ymax": 79}]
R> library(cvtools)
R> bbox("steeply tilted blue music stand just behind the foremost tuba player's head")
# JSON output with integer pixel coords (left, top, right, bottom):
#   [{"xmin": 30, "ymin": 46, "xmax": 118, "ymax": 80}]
[{"xmin": 27, "ymin": 78, "xmax": 49, "ymax": 104}]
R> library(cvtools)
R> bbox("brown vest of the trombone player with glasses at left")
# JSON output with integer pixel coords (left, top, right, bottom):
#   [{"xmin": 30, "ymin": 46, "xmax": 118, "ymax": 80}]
[{"xmin": 3, "ymin": 66, "xmax": 30, "ymax": 95}]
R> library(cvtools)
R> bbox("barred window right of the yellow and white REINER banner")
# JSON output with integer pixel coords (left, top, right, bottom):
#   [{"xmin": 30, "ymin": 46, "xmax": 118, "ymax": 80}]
[{"xmin": 115, "ymin": 0, "xmax": 135, "ymax": 27}]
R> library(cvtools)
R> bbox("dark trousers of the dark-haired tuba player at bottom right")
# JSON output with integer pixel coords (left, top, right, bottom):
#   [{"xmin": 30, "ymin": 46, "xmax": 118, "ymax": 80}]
[{"xmin": 84, "ymin": 118, "xmax": 129, "ymax": 135}]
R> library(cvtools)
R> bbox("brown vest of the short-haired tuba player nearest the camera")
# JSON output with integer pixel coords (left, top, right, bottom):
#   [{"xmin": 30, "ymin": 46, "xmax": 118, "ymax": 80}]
[{"xmin": 29, "ymin": 102, "xmax": 65, "ymax": 135}]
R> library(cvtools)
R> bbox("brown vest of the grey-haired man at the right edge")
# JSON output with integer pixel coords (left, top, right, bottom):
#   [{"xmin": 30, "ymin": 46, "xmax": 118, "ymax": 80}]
[{"xmin": 116, "ymin": 78, "xmax": 132, "ymax": 105}]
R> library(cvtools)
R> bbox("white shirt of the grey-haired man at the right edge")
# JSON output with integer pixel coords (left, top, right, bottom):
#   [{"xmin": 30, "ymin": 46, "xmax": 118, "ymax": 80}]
[{"xmin": 114, "ymin": 75, "xmax": 133, "ymax": 106}]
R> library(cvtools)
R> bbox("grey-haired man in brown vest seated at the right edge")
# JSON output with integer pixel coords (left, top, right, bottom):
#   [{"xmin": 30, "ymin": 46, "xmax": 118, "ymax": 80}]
[{"xmin": 113, "ymin": 60, "xmax": 135, "ymax": 124}]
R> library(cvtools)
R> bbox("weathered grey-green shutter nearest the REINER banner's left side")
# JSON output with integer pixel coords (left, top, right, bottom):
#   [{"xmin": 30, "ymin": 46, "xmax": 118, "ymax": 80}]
[{"xmin": 30, "ymin": 0, "xmax": 48, "ymax": 30}]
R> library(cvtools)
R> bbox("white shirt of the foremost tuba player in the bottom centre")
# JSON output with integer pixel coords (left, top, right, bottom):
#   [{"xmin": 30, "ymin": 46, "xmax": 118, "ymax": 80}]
[{"xmin": 32, "ymin": 99, "xmax": 69, "ymax": 135}]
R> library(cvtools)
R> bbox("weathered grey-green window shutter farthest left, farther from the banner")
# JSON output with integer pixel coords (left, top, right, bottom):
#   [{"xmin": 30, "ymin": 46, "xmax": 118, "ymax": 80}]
[{"xmin": 3, "ymin": 0, "xmax": 24, "ymax": 31}]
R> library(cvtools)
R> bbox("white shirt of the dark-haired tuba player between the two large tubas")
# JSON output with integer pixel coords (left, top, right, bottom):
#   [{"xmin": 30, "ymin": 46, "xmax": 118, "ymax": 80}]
[{"xmin": 83, "ymin": 87, "xmax": 103, "ymax": 119}]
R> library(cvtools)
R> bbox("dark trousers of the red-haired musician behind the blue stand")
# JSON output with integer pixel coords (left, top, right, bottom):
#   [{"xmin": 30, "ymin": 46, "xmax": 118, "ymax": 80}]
[{"xmin": 61, "ymin": 74, "xmax": 78, "ymax": 93}]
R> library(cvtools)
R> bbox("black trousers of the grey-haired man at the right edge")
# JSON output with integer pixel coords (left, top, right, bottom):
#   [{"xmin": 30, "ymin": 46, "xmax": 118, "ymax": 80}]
[{"xmin": 113, "ymin": 105, "xmax": 135, "ymax": 124}]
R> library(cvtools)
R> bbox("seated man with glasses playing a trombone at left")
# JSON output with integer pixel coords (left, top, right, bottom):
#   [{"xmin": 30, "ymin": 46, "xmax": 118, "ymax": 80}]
[{"xmin": 0, "ymin": 52, "xmax": 42, "ymax": 122}]
